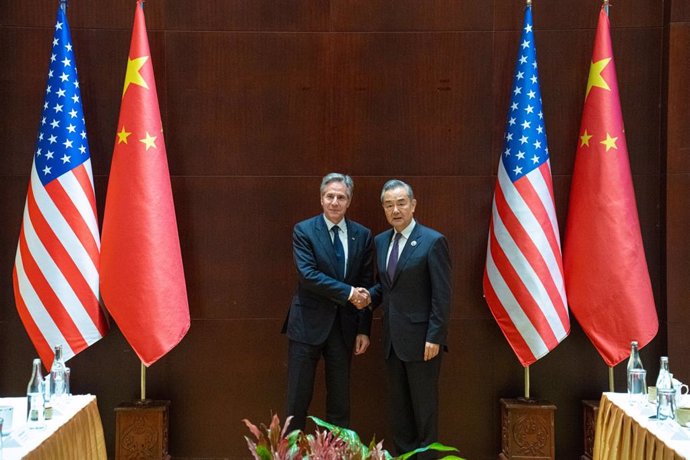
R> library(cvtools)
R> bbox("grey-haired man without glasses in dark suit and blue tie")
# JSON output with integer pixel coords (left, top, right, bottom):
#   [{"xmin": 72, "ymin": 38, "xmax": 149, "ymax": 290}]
[{"xmin": 283, "ymin": 173, "xmax": 374, "ymax": 430}]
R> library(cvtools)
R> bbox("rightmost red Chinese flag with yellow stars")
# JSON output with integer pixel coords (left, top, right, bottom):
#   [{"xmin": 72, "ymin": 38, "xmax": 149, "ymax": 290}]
[{"xmin": 563, "ymin": 8, "xmax": 659, "ymax": 366}]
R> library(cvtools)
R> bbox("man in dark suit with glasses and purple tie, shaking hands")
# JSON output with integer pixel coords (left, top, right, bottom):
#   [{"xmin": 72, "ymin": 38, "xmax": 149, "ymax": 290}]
[{"xmin": 370, "ymin": 179, "xmax": 451, "ymax": 458}]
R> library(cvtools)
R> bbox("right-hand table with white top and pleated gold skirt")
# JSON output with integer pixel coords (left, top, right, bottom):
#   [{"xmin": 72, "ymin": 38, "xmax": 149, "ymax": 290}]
[{"xmin": 593, "ymin": 393, "xmax": 690, "ymax": 460}]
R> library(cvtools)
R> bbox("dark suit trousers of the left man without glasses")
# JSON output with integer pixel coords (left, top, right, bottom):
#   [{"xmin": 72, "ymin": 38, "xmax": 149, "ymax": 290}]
[{"xmin": 287, "ymin": 316, "xmax": 352, "ymax": 430}]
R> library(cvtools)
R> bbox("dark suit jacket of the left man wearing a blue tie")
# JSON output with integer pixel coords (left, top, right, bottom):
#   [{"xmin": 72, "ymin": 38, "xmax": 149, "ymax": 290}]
[{"xmin": 283, "ymin": 214, "xmax": 374, "ymax": 348}]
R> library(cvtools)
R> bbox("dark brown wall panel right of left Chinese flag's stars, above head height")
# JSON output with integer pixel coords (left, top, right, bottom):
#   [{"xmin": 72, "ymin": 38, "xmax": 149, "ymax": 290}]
[{"xmin": 166, "ymin": 33, "xmax": 332, "ymax": 175}]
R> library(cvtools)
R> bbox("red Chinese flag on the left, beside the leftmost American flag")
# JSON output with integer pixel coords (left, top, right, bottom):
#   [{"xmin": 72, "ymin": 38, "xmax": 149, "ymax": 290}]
[{"xmin": 100, "ymin": 2, "xmax": 189, "ymax": 366}]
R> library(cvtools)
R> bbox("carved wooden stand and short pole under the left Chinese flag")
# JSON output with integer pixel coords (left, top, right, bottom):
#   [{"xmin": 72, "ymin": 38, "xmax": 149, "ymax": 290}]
[{"xmin": 115, "ymin": 362, "xmax": 170, "ymax": 460}]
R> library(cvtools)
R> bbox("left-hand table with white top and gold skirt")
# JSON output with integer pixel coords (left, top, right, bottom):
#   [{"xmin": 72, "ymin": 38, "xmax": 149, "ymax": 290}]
[{"xmin": 0, "ymin": 395, "xmax": 107, "ymax": 460}]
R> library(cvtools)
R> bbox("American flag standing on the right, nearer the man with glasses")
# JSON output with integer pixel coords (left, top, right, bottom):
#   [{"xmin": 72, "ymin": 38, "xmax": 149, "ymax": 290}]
[{"xmin": 484, "ymin": 2, "xmax": 570, "ymax": 366}]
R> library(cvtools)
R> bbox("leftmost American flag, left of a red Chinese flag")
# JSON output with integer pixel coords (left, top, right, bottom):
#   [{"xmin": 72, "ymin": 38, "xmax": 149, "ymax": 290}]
[{"xmin": 12, "ymin": 6, "xmax": 108, "ymax": 368}]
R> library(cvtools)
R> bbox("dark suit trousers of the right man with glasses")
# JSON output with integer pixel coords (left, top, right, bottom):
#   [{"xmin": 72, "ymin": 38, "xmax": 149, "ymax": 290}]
[{"xmin": 386, "ymin": 349, "xmax": 441, "ymax": 459}]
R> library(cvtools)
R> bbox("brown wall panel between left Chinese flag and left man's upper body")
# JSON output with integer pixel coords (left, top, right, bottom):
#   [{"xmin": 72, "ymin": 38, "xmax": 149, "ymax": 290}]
[{"xmin": 173, "ymin": 176, "xmax": 310, "ymax": 320}]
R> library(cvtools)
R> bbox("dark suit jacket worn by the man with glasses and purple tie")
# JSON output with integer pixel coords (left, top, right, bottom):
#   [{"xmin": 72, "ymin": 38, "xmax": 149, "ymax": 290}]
[{"xmin": 370, "ymin": 222, "xmax": 451, "ymax": 361}]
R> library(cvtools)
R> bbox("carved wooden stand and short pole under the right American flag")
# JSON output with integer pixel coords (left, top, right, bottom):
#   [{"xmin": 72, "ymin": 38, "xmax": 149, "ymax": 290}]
[{"xmin": 498, "ymin": 366, "xmax": 556, "ymax": 460}]
